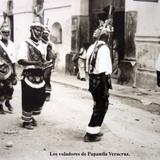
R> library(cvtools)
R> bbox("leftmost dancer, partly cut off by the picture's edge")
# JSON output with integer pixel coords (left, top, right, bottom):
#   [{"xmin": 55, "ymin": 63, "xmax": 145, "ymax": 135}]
[{"xmin": 0, "ymin": 20, "xmax": 17, "ymax": 114}]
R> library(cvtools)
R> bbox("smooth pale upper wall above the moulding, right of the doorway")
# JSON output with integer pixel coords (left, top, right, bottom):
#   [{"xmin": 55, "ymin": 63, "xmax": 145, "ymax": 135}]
[{"xmin": 125, "ymin": 0, "xmax": 160, "ymax": 36}]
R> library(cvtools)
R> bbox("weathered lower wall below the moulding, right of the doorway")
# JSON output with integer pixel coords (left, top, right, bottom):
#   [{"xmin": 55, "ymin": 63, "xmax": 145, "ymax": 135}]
[{"xmin": 136, "ymin": 37, "xmax": 160, "ymax": 89}]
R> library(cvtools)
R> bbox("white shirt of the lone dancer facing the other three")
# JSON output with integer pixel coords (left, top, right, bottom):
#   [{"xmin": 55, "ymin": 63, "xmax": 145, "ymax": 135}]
[{"xmin": 87, "ymin": 40, "xmax": 112, "ymax": 75}]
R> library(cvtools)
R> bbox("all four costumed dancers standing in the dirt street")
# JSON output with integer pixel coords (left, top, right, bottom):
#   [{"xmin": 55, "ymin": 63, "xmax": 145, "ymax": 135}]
[{"xmin": 0, "ymin": 15, "xmax": 112, "ymax": 142}]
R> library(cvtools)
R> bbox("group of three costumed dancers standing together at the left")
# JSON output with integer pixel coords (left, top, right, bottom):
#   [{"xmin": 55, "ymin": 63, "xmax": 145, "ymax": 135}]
[{"xmin": 0, "ymin": 19, "xmax": 56, "ymax": 129}]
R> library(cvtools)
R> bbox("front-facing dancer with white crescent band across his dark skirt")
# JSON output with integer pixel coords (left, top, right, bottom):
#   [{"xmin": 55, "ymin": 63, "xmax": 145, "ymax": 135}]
[{"xmin": 18, "ymin": 19, "xmax": 49, "ymax": 129}]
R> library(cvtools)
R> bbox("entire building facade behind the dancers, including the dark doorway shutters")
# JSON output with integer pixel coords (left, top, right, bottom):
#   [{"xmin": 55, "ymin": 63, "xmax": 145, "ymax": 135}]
[{"xmin": 0, "ymin": 0, "xmax": 160, "ymax": 89}]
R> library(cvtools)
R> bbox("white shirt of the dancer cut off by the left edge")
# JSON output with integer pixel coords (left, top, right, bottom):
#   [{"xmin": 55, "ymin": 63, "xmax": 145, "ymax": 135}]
[{"xmin": 0, "ymin": 40, "xmax": 16, "ymax": 63}]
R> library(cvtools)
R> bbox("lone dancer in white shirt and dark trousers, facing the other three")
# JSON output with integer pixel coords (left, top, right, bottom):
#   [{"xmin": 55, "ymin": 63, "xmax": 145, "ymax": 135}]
[{"xmin": 84, "ymin": 29, "xmax": 112, "ymax": 142}]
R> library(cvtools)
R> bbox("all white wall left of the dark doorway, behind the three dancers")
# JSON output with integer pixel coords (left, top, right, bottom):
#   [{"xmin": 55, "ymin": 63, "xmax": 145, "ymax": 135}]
[{"xmin": 0, "ymin": 0, "xmax": 88, "ymax": 71}]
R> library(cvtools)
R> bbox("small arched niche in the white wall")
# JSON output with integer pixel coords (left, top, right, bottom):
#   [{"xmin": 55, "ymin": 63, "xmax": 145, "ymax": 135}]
[{"xmin": 50, "ymin": 22, "xmax": 62, "ymax": 44}]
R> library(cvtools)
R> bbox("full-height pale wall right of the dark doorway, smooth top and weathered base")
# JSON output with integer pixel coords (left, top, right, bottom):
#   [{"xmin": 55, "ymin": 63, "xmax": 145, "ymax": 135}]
[{"xmin": 125, "ymin": 0, "xmax": 160, "ymax": 89}]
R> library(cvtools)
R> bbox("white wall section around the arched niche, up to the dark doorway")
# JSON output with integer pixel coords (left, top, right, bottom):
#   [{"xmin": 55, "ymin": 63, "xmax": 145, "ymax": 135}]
[{"xmin": 44, "ymin": 0, "xmax": 88, "ymax": 71}]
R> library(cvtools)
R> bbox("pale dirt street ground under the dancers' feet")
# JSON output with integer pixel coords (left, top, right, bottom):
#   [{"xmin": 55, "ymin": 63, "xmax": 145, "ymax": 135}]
[{"xmin": 0, "ymin": 83, "xmax": 160, "ymax": 160}]
